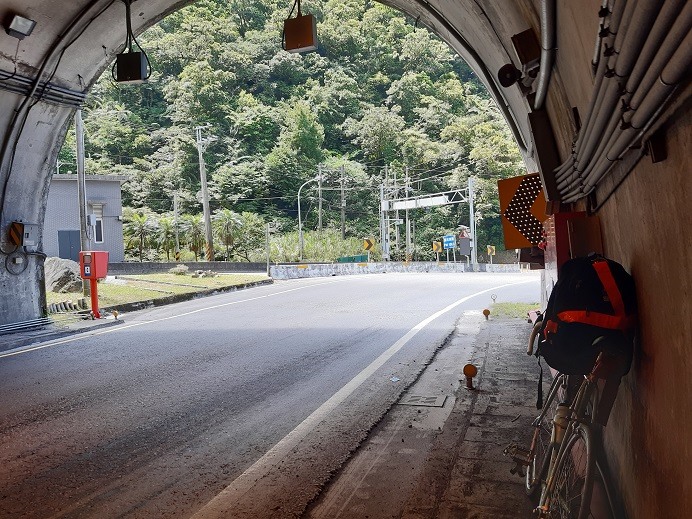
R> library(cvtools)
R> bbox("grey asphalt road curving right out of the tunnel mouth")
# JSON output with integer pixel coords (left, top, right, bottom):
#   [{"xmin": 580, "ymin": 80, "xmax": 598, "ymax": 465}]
[{"xmin": 0, "ymin": 273, "xmax": 539, "ymax": 519}]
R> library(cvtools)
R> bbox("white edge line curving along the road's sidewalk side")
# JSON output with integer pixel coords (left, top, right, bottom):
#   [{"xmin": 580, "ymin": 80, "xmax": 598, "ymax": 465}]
[{"xmin": 191, "ymin": 280, "xmax": 534, "ymax": 519}]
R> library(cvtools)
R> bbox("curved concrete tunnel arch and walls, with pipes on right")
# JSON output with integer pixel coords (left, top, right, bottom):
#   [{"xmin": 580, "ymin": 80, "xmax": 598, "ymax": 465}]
[{"xmin": 0, "ymin": 0, "xmax": 692, "ymax": 518}]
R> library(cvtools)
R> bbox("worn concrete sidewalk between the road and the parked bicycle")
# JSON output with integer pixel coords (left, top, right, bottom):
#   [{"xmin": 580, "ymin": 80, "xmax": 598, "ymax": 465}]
[{"xmin": 306, "ymin": 314, "xmax": 538, "ymax": 519}]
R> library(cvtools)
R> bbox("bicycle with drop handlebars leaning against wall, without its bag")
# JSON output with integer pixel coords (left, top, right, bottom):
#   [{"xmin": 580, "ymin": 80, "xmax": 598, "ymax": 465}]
[{"xmin": 504, "ymin": 336, "xmax": 622, "ymax": 519}]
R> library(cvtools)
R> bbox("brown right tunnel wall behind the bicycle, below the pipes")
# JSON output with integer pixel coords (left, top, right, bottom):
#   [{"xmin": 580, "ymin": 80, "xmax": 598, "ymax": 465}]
[{"xmin": 600, "ymin": 109, "xmax": 692, "ymax": 518}]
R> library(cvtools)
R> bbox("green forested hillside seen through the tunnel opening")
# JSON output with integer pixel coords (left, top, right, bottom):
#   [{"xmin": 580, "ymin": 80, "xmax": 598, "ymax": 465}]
[{"xmin": 60, "ymin": 0, "xmax": 522, "ymax": 261}]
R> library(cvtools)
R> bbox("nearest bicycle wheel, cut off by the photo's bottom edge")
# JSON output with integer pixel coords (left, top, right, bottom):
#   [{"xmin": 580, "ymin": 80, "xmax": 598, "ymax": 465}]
[{"xmin": 548, "ymin": 424, "xmax": 595, "ymax": 519}]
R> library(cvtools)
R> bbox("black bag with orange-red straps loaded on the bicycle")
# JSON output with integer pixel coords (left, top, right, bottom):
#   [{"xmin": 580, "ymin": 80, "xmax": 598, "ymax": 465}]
[{"xmin": 537, "ymin": 254, "xmax": 637, "ymax": 375}]
